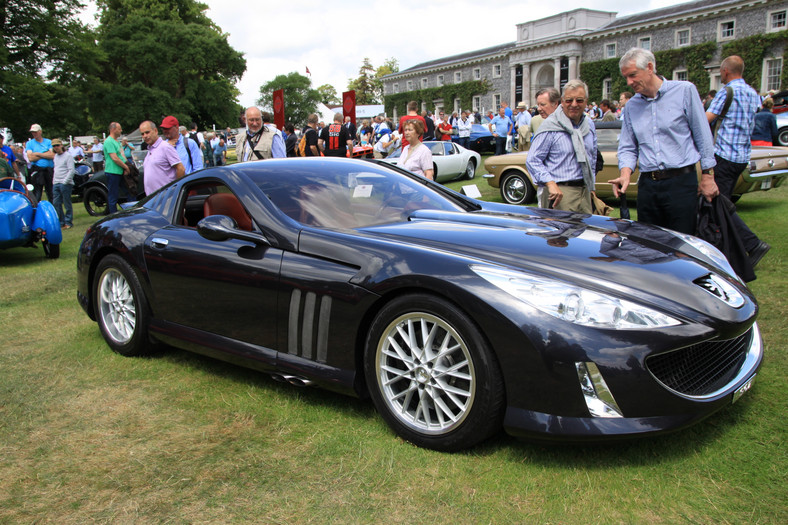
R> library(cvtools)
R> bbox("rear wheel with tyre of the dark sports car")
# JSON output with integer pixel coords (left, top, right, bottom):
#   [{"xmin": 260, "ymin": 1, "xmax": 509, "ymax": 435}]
[{"xmin": 93, "ymin": 254, "xmax": 153, "ymax": 356}]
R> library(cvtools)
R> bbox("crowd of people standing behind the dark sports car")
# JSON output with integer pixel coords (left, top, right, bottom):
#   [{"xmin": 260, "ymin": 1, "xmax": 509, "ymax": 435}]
[{"xmin": 0, "ymin": 48, "xmax": 777, "ymax": 278}]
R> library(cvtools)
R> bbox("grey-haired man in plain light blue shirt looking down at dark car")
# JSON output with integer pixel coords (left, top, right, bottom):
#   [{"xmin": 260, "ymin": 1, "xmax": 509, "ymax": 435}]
[{"xmin": 610, "ymin": 48, "xmax": 719, "ymax": 234}]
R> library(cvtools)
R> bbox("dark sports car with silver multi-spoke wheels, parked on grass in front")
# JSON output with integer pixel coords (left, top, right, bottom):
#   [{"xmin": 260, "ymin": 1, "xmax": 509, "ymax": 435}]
[{"xmin": 78, "ymin": 158, "xmax": 762, "ymax": 450}]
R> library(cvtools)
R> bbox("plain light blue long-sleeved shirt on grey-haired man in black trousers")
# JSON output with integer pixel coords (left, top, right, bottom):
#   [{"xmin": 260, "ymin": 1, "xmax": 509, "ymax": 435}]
[{"xmin": 618, "ymin": 80, "xmax": 716, "ymax": 171}]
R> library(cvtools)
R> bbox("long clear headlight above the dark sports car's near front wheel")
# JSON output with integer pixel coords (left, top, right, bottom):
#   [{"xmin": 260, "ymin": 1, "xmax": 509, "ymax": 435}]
[{"xmin": 471, "ymin": 265, "xmax": 681, "ymax": 330}]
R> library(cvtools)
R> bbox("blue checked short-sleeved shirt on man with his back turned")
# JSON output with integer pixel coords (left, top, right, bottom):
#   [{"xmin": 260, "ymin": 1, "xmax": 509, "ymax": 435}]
[{"xmin": 708, "ymin": 78, "xmax": 761, "ymax": 163}]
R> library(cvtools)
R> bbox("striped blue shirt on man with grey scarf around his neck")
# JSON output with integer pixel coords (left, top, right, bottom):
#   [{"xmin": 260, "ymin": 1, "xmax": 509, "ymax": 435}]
[{"xmin": 525, "ymin": 115, "xmax": 597, "ymax": 185}]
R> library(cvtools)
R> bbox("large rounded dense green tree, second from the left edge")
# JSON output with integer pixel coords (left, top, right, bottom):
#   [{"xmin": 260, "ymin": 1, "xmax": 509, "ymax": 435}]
[{"xmin": 89, "ymin": 0, "xmax": 246, "ymax": 129}]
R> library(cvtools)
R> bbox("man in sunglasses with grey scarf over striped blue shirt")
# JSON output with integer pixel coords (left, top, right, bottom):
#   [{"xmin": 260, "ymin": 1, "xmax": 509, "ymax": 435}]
[{"xmin": 525, "ymin": 80, "xmax": 597, "ymax": 214}]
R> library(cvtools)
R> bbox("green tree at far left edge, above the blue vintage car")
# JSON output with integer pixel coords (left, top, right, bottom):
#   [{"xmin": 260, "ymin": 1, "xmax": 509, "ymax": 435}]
[{"xmin": 0, "ymin": 0, "xmax": 98, "ymax": 140}]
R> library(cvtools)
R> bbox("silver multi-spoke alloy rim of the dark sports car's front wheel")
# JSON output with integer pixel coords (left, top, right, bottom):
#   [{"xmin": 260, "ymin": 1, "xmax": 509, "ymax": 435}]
[{"xmin": 375, "ymin": 312, "xmax": 477, "ymax": 435}]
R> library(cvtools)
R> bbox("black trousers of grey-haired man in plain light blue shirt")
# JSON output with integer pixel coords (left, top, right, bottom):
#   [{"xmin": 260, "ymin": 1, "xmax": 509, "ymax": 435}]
[{"xmin": 638, "ymin": 172, "xmax": 698, "ymax": 235}]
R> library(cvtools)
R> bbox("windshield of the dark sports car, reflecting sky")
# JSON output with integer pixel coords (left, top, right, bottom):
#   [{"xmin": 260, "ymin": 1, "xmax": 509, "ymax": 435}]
[{"xmin": 246, "ymin": 161, "xmax": 465, "ymax": 229}]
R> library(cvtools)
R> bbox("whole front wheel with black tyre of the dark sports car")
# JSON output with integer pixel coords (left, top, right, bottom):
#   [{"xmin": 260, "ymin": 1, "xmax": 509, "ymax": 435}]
[{"xmin": 364, "ymin": 294, "xmax": 504, "ymax": 451}]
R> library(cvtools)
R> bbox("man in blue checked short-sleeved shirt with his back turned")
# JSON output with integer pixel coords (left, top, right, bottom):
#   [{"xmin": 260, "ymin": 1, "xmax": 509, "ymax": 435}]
[{"xmin": 706, "ymin": 55, "xmax": 771, "ymax": 266}]
